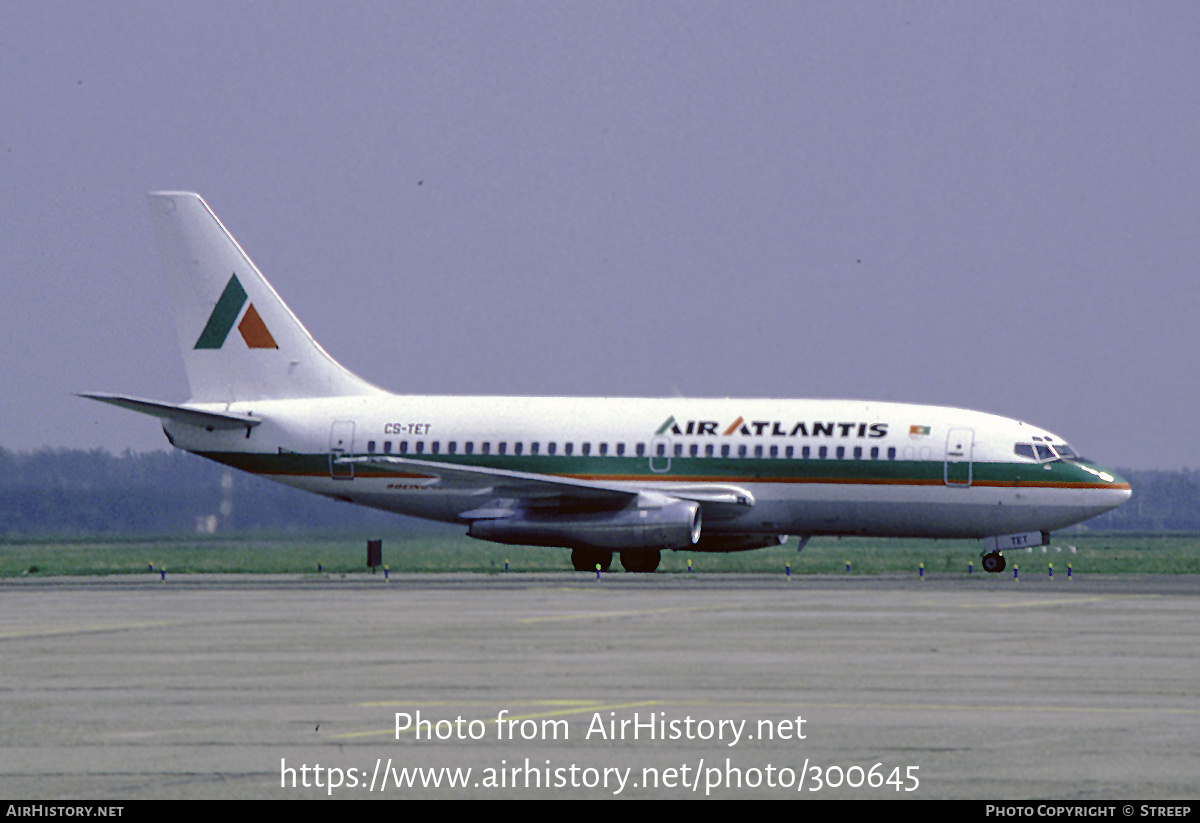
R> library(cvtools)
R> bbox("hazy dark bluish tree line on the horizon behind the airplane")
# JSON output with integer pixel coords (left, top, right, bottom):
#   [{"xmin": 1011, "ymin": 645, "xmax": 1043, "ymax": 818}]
[{"xmin": 0, "ymin": 449, "xmax": 1185, "ymax": 536}]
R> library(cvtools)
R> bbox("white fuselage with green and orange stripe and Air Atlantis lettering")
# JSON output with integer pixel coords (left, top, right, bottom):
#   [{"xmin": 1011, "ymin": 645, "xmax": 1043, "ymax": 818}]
[{"xmin": 167, "ymin": 395, "xmax": 1130, "ymax": 537}]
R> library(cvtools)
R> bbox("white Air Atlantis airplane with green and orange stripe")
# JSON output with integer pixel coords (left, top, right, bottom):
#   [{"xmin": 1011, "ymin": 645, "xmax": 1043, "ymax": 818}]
[{"xmin": 80, "ymin": 192, "xmax": 1132, "ymax": 572}]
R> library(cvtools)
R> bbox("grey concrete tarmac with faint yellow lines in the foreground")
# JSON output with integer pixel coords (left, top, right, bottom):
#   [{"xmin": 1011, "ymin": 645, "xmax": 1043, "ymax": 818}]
[{"xmin": 0, "ymin": 573, "xmax": 1200, "ymax": 801}]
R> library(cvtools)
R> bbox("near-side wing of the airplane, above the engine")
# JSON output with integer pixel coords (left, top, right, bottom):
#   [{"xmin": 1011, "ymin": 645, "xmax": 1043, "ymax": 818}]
[{"xmin": 337, "ymin": 455, "xmax": 754, "ymax": 519}]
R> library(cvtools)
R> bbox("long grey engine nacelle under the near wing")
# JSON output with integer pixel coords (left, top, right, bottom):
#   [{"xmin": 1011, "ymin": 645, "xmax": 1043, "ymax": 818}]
[{"xmin": 467, "ymin": 500, "xmax": 700, "ymax": 551}]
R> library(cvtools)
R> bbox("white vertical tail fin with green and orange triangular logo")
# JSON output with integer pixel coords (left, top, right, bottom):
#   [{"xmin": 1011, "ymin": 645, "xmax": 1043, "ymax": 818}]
[{"xmin": 149, "ymin": 192, "xmax": 379, "ymax": 403}]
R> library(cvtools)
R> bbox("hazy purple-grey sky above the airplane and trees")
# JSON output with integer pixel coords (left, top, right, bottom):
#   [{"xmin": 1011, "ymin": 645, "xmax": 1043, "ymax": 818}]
[{"xmin": 0, "ymin": 1, "xmax": 1200, "ymax": 468}]
